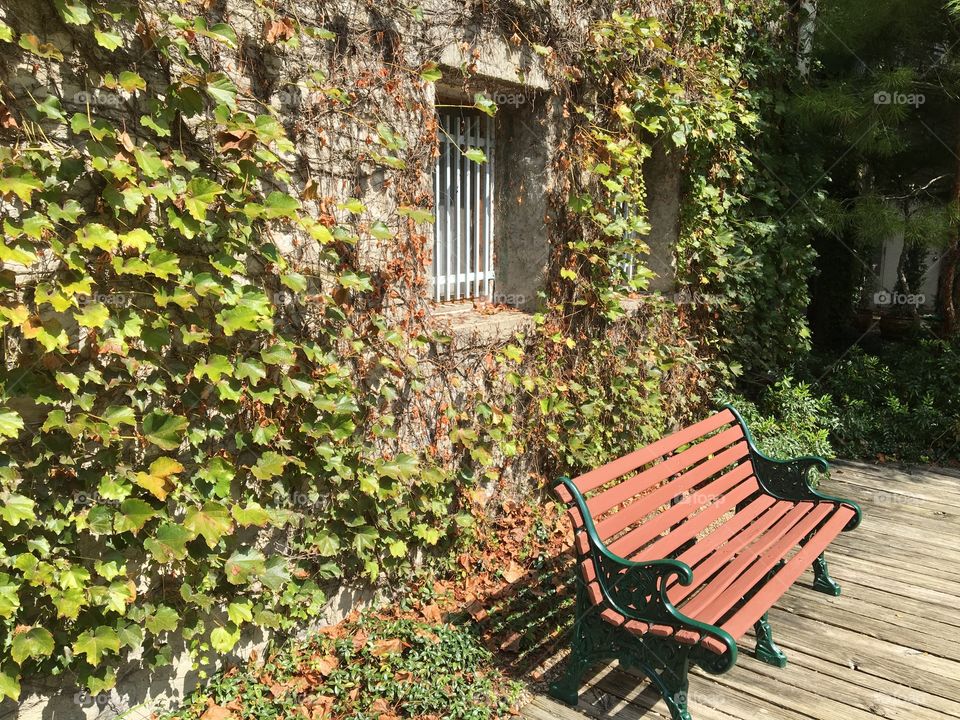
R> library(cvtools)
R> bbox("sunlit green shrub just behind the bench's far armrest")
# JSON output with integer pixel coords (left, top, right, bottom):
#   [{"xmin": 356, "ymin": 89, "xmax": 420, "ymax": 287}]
[{"xmin": 721, "ymin": 377, "xmax": 837, "ymax": 459}]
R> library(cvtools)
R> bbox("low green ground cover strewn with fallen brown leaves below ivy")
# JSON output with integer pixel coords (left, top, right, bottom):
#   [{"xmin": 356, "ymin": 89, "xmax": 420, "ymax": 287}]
[{"xmin": 164, "ymin": 615, "xmax": 521, "ymax": 720}]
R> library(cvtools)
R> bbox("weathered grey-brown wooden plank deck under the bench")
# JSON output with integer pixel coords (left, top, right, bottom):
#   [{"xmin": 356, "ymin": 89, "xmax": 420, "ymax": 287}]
[{"xmin": 521, "ymin": 463, "xmax": 960, "ymax": 720}]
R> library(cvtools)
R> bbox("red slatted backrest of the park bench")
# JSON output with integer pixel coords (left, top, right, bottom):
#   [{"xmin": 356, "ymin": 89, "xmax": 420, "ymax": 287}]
[{"xmin": 557, "ymin": 409, "xmax": 760, "ymax": 575}]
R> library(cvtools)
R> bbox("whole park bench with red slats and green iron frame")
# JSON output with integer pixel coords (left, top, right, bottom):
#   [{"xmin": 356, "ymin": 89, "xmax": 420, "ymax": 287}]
[{"xmin": 550, "ymin": 405, "xmax": 860, "ymax": 720}]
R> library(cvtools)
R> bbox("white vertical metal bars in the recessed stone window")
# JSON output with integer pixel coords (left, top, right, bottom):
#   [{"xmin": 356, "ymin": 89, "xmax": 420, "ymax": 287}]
[{"xmin": 431, "ymin": 111, "xmax": 495, "ymax": 301}]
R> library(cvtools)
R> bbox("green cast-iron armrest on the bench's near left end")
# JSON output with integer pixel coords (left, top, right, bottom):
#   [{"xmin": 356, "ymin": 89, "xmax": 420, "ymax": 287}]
[{"xmin": 554, "ymin": 477, "xmax": 737, "ymax": 674}]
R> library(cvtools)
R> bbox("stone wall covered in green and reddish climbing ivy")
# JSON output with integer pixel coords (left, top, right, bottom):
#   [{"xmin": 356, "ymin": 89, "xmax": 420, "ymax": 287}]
[{"xmin": 0, "ymin": 0, "xmax": 809, "ymax": 712}]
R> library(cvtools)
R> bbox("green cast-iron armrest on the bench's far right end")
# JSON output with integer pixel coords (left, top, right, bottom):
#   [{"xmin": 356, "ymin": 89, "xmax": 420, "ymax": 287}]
[{"xmin": 723, "ymin": 403, "xmax": 863, "ymax": 531}]
